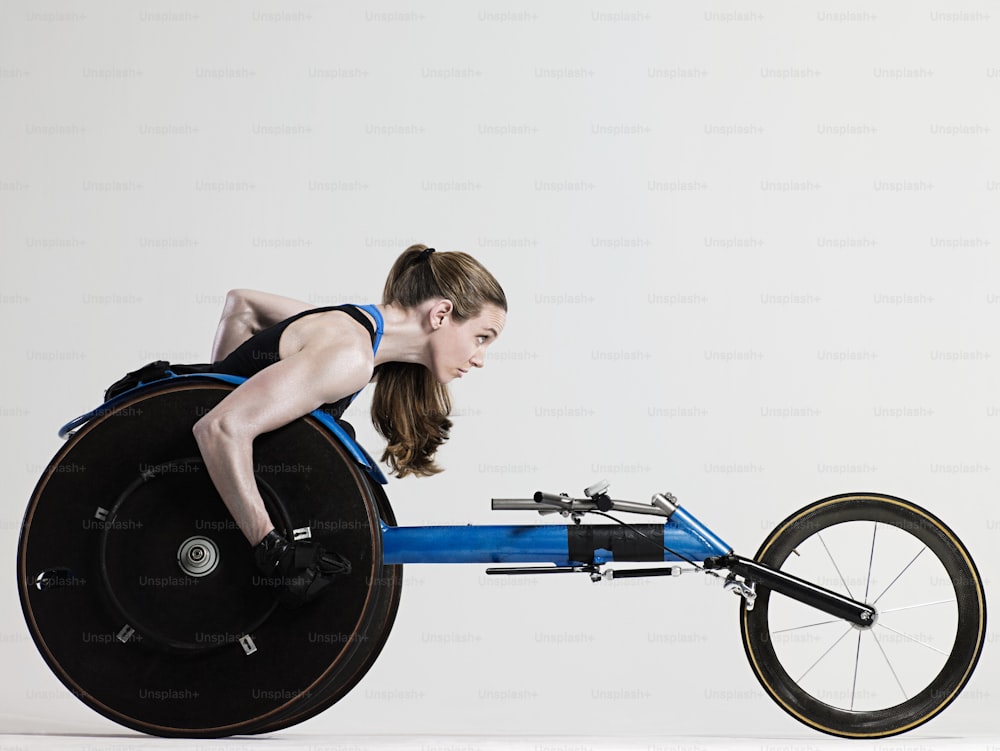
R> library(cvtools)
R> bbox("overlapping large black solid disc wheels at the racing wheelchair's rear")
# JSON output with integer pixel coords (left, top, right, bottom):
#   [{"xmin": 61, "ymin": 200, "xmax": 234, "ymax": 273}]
[{"xmin": 17, "ymin": 379, "xmax": 400, "ymax": 737}]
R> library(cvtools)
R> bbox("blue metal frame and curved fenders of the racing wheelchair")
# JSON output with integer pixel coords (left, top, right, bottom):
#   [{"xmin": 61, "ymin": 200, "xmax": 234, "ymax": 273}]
[{"xmin": 59, "ymin": 370, "xmax": 733, "ymax": 565}]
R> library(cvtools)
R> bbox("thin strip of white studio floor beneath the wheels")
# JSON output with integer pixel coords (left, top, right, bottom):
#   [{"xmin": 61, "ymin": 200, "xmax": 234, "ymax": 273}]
[{"xmin": 0, "ymin": 731, "xmax": 1000, "ymax": 751}]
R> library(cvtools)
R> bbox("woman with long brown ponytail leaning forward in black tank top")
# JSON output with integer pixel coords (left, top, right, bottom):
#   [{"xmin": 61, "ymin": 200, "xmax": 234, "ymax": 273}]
[{"xmin": 194, "ymin": 245, "xmax": 507, "ymax": 606}]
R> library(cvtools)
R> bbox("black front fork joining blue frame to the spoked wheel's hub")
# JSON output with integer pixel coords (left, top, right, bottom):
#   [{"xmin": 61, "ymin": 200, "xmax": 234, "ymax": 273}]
[{"xmin": 704, "ymin": 553, "xmax": 876, "ymax": 628}]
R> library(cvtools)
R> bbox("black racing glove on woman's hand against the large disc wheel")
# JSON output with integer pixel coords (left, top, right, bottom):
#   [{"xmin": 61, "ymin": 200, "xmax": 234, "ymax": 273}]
[{"xmin": 253, "ymin": 529, "xmax": 351, "ymax": 608}]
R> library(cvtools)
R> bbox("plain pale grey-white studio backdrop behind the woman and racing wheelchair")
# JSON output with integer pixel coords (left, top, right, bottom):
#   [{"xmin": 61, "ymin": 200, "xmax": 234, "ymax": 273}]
[{"xmin": 0, "ymin": 0, "xmax": 1000, "ymax": 742}]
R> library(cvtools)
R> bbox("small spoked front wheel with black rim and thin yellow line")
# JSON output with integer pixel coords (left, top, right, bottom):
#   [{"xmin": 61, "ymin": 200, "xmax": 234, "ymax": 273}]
[{"xmin": 740, "ymin": 493, "xmax": 986, "ymax": 738}]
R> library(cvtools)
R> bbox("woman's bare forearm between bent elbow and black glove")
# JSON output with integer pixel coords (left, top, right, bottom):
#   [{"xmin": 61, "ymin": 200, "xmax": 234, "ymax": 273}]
[{"xmin": 194, "ymin": 427, "xmax": 274, "ymax": 545}]
